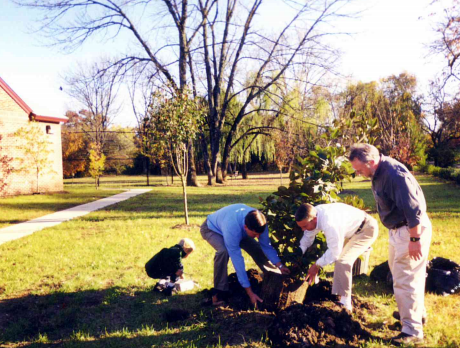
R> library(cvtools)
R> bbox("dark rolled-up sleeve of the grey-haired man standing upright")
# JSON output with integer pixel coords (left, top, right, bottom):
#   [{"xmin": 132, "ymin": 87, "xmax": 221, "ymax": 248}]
[{"xmin": 391, "ymin": 174, "xmax": 426, "ymax": 228}]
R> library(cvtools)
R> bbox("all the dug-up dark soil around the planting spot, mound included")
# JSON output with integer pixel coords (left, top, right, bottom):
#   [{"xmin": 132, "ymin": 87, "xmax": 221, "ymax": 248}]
[{"xmin": 201, "ymin": 276, "xmax": 376, "ymax": 348}]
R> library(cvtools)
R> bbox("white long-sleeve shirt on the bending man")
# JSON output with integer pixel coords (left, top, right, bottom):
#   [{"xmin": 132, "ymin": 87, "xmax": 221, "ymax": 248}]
[{"xmin": 300, "ymin": 203, "xmax": 366, "ymax": 267}]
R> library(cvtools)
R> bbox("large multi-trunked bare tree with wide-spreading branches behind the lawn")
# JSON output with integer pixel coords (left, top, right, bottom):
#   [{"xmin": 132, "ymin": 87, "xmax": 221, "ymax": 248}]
[{"xmin": 15, "ymin": 0, "xmax": 352, "ymax": 182}]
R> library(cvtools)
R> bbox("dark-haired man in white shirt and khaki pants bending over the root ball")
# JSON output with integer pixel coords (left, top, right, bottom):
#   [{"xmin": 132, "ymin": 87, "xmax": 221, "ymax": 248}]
[{"xmin": 295, "ymin": 203, "xmax": 379, "ymax": 311}]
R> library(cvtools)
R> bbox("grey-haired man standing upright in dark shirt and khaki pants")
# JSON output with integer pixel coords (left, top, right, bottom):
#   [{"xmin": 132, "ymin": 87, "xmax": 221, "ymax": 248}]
[{"xmin": 349, "ymin": 144, "xmax": 431, "ymax": 345}]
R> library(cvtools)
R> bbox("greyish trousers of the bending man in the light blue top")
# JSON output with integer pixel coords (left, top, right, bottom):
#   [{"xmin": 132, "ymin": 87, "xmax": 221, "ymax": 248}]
[{"xmin": 200, "ymin": 220, "xmax": 276, "ymax": 291}]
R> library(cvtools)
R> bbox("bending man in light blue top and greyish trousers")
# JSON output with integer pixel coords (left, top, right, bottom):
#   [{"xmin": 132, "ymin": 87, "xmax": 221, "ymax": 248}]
[{"xmin": 201, "ymin": 204, "xmax": 290, "ymax": 306}]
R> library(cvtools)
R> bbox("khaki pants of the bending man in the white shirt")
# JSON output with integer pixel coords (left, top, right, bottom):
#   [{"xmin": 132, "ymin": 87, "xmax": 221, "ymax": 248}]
[{"xmin": 332, "ymin": 215, "xmax": 379, "ymax": 297}]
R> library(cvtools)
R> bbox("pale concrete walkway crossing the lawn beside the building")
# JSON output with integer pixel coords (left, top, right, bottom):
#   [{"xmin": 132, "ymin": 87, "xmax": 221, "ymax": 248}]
[{"xmin": 0, "ymin": 189, "xmax": 150, "ymax": 244}]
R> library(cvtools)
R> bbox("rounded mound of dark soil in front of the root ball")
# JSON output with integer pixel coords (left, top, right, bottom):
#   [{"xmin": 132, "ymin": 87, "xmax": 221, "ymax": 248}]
[{"xmin": 268, "ymin": 302, "xmax": 371, "ymax": 348}]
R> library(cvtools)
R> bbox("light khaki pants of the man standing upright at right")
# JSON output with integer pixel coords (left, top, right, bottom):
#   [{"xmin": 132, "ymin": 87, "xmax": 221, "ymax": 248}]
[{"xmin": 388, "ymin": 215, "xmax": 432, "ymax": 338}]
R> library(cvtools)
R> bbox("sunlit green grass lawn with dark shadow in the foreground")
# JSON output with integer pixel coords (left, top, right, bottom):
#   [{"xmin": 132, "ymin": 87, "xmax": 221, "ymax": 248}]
[{"xmin": 0, "ymin": 174, "xmax": 460, "ymax": 348}]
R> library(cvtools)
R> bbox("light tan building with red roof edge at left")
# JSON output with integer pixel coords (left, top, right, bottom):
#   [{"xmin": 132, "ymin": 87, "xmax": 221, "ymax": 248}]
[{"xmin": 0, "ymin": 77, "xmax": 67, "ymax": 196}]
